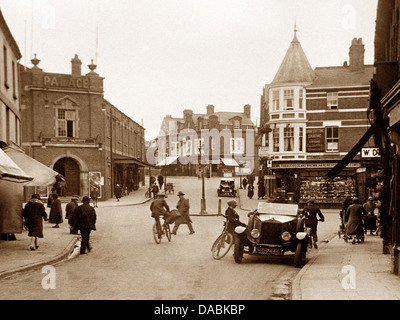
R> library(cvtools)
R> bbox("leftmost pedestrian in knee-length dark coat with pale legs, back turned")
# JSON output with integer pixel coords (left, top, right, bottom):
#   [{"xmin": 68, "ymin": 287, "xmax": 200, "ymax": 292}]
[{"xmin": 22, "ymin": 193, "xmax": 47, "ymax": 250}]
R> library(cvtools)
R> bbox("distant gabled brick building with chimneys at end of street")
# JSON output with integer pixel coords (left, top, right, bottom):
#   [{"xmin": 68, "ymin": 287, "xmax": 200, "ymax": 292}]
[{"xmin": 156, "ymin": 105, "xmax": 256, "ymax": 177}]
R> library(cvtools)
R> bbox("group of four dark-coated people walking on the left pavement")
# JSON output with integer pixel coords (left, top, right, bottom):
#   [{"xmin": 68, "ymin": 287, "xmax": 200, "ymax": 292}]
[{"xmin": 22, "ymin": 190, "xmax": 97, "ymax": 254}]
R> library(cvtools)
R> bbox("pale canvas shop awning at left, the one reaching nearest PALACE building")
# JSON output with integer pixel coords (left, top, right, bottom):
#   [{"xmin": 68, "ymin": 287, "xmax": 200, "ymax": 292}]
[{"xmin": 3, "ymin": 147, "xmax": 59, "ymax": 186}]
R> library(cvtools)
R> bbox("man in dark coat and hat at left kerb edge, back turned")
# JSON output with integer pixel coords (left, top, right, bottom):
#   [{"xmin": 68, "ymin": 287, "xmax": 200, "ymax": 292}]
[{"xmin": 75, "ymin": 196, "xmax": 97, "ymax": 254}]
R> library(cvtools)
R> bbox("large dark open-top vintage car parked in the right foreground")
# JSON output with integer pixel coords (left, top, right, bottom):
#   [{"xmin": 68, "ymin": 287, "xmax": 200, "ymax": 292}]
[{"xmin": 233, "ymin": 202, "xmax": 309, "ymax": 268}]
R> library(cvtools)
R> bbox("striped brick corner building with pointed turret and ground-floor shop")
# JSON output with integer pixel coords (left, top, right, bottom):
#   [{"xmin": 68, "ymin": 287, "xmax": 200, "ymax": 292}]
[{"xmin": 259, "ymin": 29, "xmax": 378, "ymax": 207}]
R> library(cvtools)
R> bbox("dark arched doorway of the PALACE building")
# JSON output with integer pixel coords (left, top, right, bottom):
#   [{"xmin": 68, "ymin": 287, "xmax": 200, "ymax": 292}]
[{"xmin": 53, "ymin": 158, "xmax": 80, "ymax": 196}]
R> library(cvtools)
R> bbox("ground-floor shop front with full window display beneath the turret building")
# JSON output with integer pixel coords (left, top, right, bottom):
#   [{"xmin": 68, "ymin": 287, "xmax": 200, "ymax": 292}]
[{"xmin": 268, "ymin": 161, "xmax": 377, "ymax": 209}]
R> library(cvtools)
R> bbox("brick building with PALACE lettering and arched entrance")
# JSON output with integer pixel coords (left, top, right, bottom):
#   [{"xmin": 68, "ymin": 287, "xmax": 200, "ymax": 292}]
[{"xmin": 20, "ymin": 55, "xmax": 146, "ymax": 199}]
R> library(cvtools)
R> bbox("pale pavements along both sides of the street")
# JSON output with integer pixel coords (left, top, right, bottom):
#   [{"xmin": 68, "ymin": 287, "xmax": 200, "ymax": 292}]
[{"xmin": 0, "ymin": 181, "xmax": 400, "ymax": 300}]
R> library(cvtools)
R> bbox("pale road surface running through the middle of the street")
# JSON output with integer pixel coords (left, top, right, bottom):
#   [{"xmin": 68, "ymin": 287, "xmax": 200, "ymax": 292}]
[{"xmin": 0, "ymin": 179, "xmax": 337, "ymax": 300}]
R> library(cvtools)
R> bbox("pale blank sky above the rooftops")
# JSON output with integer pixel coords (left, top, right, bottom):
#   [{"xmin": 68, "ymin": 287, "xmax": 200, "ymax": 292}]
[{"xmin": 0, "ymin": 0, "xmax": 377, "ymax": 140}]
